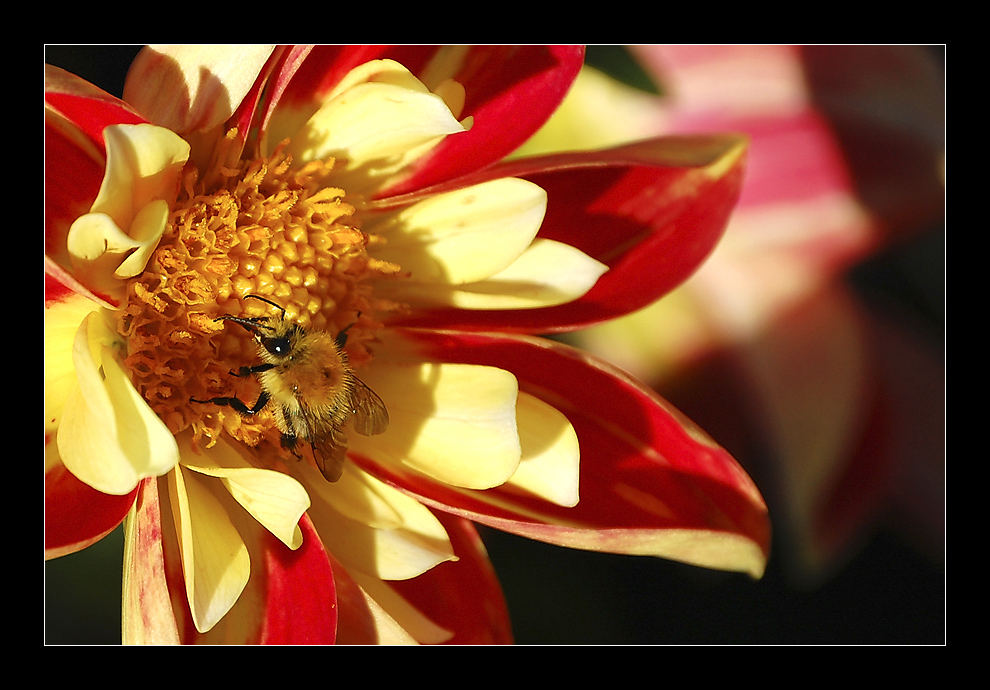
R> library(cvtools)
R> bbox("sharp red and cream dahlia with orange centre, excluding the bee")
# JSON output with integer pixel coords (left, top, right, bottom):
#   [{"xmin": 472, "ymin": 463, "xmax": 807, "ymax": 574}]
[{"xmin": 45, "ymin": 46, "xmax": 769, "ymax": 642}]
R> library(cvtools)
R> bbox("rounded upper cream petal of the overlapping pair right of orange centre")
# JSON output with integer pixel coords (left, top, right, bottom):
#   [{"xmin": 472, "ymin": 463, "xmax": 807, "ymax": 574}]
[{"xmin": 365, "ymin": 177, "xmax": 547, "ymax": 288}]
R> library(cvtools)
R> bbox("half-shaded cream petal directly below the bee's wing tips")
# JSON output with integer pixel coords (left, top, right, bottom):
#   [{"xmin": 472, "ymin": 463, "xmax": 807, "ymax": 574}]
[{"xmin": 306, "ymin": 463, "xmax": 455, "ymax": 580}]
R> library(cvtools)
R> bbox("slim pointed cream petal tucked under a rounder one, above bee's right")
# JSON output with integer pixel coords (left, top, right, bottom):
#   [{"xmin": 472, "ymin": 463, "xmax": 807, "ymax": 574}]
[{"xmin": 392, "ymin": 239, "xmax": 608, "ymax": 309}]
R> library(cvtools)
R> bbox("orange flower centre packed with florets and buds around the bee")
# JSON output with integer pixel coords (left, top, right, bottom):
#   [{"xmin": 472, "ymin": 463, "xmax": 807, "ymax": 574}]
[{"xmin": 118, "ymin": 131, "xmax": 398, "ymax": 446}]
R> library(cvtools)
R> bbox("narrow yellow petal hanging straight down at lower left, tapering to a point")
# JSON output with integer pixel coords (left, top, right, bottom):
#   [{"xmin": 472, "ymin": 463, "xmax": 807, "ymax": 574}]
[{"xmin": 168, "ymin": 465, "xmax": 251, "ymax": 632}]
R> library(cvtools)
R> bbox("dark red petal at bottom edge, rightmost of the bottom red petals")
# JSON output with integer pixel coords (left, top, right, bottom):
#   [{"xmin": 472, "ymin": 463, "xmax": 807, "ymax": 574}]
[{"xmin": 390, "ymin": 512, "xmax": 512, "ymax": 644}]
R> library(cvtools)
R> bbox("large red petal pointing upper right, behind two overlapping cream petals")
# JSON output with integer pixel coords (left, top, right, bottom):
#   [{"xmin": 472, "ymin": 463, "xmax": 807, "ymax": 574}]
[{"xmin": 392, "ymin": 135, "xmax": 745, "ymax": 333}]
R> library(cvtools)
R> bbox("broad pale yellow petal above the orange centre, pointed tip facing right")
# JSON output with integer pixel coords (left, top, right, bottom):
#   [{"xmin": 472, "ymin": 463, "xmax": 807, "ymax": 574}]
[{"xmin": 278, "ymin": 57, "xmax": 465, "ymax": 191}]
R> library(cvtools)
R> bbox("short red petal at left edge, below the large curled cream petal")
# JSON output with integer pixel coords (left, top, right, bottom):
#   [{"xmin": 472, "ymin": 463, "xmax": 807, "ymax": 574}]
[{"xmin": 45, "ymin": 460, "xmax": 137, "ymax": 558}]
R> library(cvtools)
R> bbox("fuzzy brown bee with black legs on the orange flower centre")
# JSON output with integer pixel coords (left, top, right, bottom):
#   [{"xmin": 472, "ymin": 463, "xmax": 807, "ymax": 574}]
[{"xmin": 191, "ymin": 295, "xmax": 388, "ymax": 482}]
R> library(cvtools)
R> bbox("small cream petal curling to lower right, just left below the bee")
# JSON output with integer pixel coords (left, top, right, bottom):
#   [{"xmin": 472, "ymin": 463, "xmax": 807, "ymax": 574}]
[{"xmin": 182, "ymin": 439, "xmax": 309, "ymax": 549}]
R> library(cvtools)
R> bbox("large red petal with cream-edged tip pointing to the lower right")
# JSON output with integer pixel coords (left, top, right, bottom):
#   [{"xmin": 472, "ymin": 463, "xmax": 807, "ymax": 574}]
[{"xmin": 359, "ymin": 332, "xmax": 770, "ymax": 575}]
